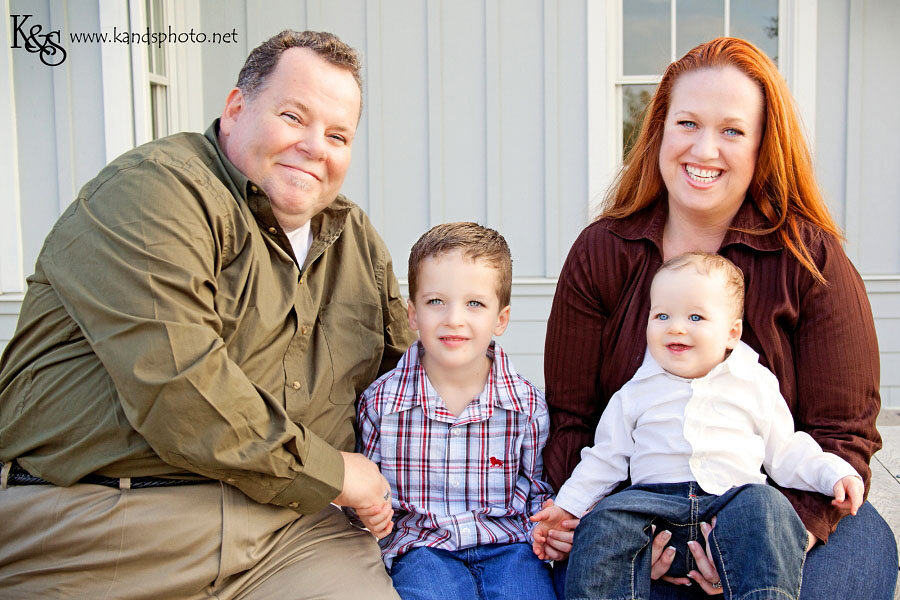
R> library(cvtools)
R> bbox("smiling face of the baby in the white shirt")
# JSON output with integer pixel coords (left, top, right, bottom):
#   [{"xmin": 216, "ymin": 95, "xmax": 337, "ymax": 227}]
[{"xmin": 647, "ymin": 265, "xmax": 742, "ymax": 379}]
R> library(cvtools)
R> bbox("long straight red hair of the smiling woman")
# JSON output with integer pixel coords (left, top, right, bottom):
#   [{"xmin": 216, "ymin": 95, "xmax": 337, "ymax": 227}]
[{"xmin": 598, "ymin": 38, "xmax": 841, "ymax": 282}]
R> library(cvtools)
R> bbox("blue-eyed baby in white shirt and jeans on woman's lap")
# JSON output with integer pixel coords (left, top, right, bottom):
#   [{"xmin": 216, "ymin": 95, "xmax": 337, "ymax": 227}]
[{"xmin": 533, "ymin": 253, "xmax": 863, "ymax": 599}]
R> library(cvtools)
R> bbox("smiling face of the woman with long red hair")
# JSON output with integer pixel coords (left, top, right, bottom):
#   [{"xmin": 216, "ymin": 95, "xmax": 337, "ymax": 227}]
[{"xmin": 659, "ymin": 67, "xmax": 764, "ymax": 226}]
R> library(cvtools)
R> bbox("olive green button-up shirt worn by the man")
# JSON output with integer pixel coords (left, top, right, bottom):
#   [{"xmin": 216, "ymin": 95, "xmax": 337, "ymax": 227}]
[{"xmin": 0, "ymin": 122, "xmax": 414, "ymax": 512}]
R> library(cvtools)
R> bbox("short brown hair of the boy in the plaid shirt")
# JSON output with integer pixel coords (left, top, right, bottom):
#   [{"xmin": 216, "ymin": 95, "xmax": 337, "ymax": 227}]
[{"xmin": 407, "ymin": 221, "xmax": 512, "ymax": 309}]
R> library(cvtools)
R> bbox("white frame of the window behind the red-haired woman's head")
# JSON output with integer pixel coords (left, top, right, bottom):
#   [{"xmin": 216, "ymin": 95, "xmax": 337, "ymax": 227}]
[{"xmin": 587, "ymin": 0, "xmax": 818, "ymax": 214}]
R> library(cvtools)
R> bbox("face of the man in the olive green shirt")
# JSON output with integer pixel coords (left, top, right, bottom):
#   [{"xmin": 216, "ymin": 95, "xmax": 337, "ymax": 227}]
[{"xmin": 219, "ymin": 48, "xmax": 361, "ymax": 231}]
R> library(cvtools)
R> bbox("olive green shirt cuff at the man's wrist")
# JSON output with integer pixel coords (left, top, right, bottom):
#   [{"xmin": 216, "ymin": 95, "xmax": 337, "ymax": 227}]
[{"xmin": 270, "ymin": 435, "xmax": 344, "ymax": 514}]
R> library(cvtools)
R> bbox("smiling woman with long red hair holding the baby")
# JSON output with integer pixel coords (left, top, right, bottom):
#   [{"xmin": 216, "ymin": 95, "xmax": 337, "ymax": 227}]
[{"xmin": 544, "ymin": 38, "xmax": 897, "ymax": 600}]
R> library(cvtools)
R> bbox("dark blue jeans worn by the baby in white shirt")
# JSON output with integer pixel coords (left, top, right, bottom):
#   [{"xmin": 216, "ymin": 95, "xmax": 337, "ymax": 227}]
[{"xmin": 566, "ymin": 482, "xmax": 807, "ymax": 600}]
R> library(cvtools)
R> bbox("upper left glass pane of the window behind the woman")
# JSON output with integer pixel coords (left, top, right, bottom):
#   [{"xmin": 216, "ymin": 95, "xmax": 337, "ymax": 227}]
[{"xmin": 622, "ymin": 0, "xmax": 672, "ymax": 75}]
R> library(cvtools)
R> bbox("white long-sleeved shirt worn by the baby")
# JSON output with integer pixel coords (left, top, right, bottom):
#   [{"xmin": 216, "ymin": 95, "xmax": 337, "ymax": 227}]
[{"xmin": 555, "ymin": 342, "xmax": 859, "ymax": 516}]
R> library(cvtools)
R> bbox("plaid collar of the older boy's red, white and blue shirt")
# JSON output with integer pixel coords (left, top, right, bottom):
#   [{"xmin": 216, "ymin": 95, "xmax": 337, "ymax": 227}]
[{"xmin": 384, "ymin": 340, "xmax": 530, "ymax": 425}]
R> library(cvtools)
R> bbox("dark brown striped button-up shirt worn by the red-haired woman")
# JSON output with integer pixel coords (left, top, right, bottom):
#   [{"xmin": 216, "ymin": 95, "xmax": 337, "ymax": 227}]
[{"xmin": 544, "ymin": 200, "xmax": 881, "ymax": 540}]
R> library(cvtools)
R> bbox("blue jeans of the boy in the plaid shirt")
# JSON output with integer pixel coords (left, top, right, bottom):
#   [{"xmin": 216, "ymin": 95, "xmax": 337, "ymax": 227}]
[{"xmin": 391, "ymin": 543, "xmax": 556, "ymax": 600}]
